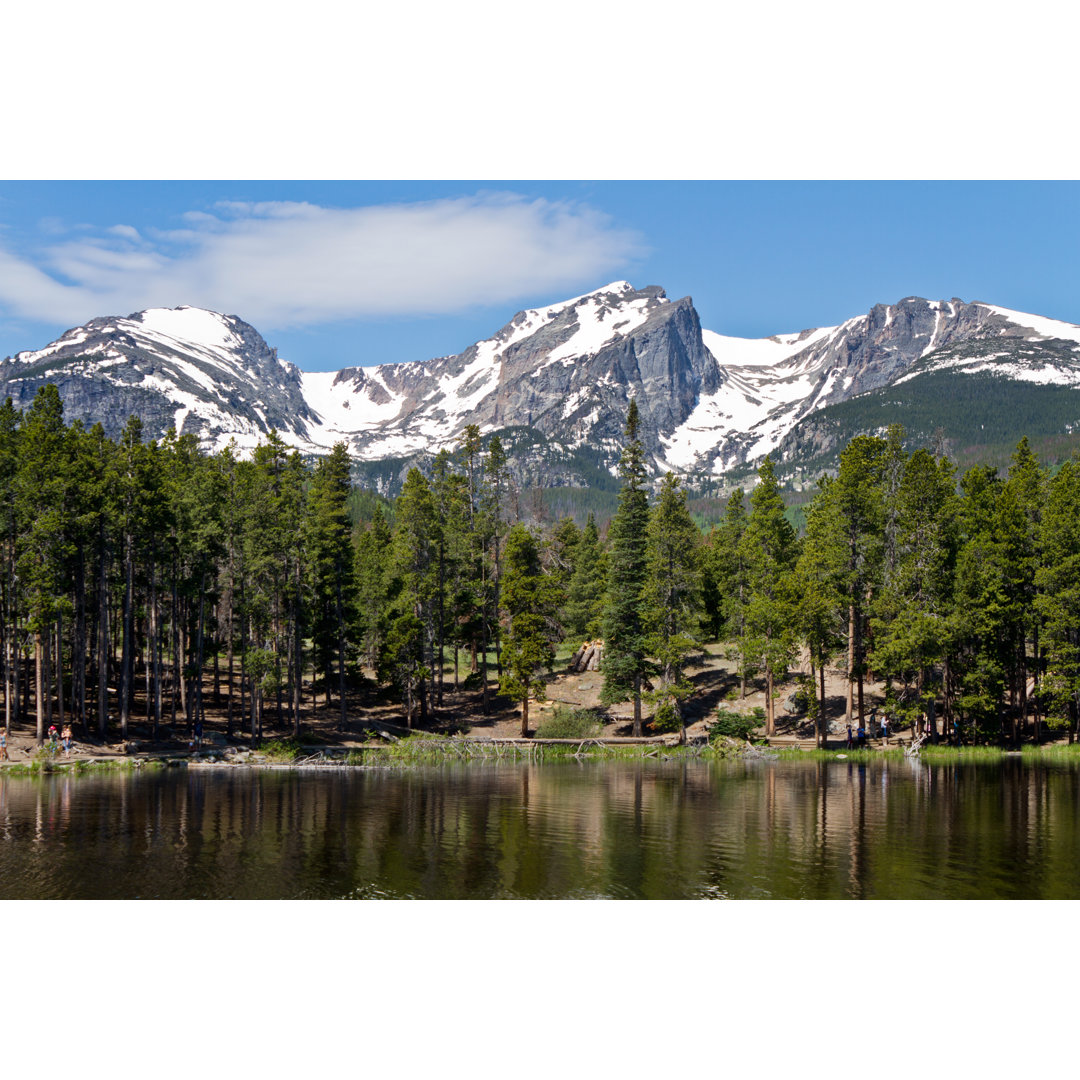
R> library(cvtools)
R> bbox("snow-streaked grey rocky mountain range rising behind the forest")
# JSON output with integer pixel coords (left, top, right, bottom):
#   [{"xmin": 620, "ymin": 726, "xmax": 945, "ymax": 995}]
[{"xmin": 0, "ymin": 281, "xmax": 1080, "ymax": 486}]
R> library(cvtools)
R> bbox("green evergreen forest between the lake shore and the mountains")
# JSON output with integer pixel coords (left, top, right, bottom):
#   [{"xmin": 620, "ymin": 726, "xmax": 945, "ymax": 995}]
[{"xmin": 0, "ymin": 386, "xmax": 1080, "ymax": 744}]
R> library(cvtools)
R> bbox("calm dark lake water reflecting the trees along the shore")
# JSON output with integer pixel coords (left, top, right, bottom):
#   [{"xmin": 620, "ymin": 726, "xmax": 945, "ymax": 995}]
[{"xmin": 0, "ymin": 759, "xmax": 1080, "ymax": 900}]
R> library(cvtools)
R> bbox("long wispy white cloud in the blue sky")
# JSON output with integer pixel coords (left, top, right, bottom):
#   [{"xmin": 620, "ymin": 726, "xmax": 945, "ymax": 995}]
[{"xmin": 0, "ymin": 192, "xmax": 640, "ymax": 328}]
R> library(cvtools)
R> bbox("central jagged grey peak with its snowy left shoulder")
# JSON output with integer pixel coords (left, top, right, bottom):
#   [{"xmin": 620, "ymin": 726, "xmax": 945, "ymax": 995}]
[{"xmin": 305, "ymin": 282, "xmax": 720, "ymax": 468}]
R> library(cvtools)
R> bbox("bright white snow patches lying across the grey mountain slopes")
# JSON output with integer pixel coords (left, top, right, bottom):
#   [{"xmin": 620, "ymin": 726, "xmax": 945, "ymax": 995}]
[{"xmin": 8, "ymin": 291, "xmax": 1080, "ymax": 472}]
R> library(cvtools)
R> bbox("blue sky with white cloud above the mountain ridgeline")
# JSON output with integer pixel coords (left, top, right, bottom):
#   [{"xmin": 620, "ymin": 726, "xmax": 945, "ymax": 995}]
[{"xmin": 0, "ymin": 180, "xmax": 1080, "ymax": 370}]
